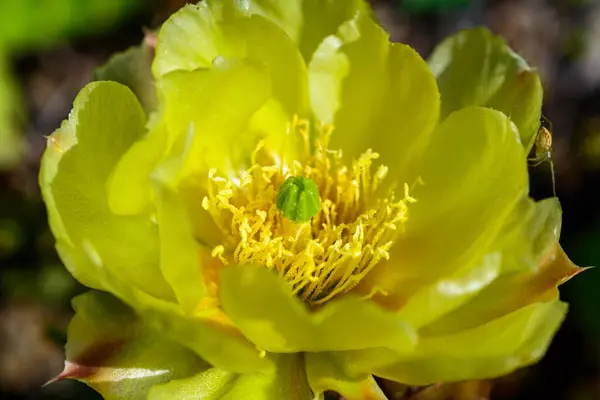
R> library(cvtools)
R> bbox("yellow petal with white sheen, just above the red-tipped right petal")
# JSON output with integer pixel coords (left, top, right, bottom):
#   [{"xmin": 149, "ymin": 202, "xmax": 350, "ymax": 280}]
[{"xmin": 399, "ymin": 197, "xmax": 568, "ymax": 327}]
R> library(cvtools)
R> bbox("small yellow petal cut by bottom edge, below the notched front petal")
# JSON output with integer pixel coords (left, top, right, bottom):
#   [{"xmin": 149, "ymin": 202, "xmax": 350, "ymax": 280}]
[{"xmin": 304, "ymin": 353, "xmax": 387, "ymax": 400}]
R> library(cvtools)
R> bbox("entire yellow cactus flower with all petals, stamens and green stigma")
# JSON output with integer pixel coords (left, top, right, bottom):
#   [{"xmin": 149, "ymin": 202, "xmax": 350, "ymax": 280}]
[{"xmin": 40, "ymin": 0, "xmax": 582, "ymax": 400}]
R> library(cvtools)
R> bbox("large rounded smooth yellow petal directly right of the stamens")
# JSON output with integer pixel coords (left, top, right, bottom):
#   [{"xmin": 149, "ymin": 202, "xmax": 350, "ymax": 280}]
[{"xmin": 361, "ymin": 107, "xmax": 528, "ymax": 310}]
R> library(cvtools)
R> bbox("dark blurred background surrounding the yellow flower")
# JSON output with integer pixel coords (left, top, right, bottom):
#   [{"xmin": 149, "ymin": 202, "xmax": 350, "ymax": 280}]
[{"xmin": 0, "ymin": 0, "xmax": 600, "ymax": 400}]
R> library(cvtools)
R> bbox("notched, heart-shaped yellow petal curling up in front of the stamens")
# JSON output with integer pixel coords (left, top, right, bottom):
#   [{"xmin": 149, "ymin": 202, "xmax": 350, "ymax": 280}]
[{"xmin": 220, "ymin": 265, "xmax": 415, "ymax": 353}]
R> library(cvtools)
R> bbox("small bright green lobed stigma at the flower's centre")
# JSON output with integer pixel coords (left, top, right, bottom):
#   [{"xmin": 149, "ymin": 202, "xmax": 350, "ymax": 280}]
[{"xmin": 275, "ymin": 176, "xmax": 321, "ymax": 223}]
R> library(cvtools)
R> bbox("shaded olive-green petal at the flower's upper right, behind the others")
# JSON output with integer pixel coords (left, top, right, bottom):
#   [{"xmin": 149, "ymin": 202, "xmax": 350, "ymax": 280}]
[{"xmin": 429, "ymin": 28, "xmax": 543, "ymax": 152}]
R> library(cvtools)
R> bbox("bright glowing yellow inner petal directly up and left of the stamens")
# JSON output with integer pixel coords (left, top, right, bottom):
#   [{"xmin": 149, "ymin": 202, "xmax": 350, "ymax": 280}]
[{"xmin": 158, "ymin": 60, "xmax": 271, "ymax": 181}]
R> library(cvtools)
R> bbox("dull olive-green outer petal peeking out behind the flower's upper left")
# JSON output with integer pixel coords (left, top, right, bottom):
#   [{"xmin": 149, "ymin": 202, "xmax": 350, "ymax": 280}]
[{"xmin": 94, "ymin": 43, "xmax": 158, "ymax": 114}]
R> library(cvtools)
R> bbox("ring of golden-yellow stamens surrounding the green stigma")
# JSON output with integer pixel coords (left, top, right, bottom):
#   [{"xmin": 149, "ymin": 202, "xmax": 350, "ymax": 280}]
[{"xmin": 202, "ymin": 119, "xmax": 416, "ymax": 305}]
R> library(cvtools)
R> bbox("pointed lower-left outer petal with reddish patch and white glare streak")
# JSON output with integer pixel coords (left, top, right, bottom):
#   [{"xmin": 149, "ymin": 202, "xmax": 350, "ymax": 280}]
[{"xmin": 54, "ymin": 292, "xmax": 208, "ymax": 400}]
